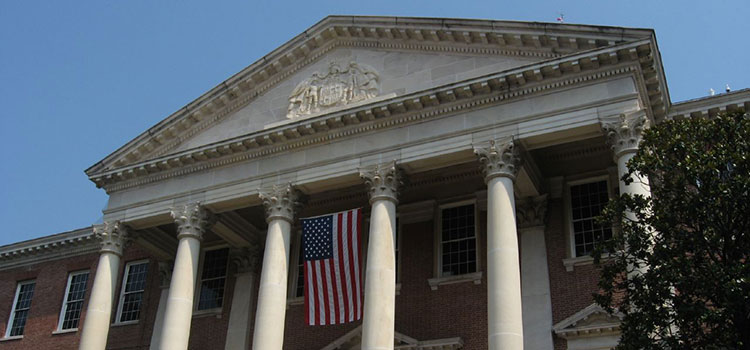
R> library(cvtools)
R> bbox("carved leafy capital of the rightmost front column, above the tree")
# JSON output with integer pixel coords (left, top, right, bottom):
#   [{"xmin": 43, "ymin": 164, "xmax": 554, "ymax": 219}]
[{"xmin": 602, "ymin": 111, "xmax": 649, "ymax": 161}]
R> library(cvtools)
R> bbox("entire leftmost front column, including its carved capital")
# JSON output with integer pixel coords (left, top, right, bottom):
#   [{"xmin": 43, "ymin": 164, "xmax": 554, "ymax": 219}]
[{"xmin": 78, "ymin": 221, "xmax": 128, "ymax": 350}]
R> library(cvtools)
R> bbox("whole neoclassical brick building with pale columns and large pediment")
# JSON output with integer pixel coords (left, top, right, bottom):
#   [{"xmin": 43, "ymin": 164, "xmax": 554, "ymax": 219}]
[{"xmin": 0, "ymin": 16, "xmax": 750, "ymax": 350}]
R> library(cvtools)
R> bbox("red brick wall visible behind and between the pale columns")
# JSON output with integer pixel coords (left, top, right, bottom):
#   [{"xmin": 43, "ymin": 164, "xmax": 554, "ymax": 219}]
[{"xmin": 0, "ymin": 199, "xmax": 598, "ymax": 350}]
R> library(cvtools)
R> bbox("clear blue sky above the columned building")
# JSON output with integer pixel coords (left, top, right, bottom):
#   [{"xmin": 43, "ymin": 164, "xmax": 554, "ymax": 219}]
[{"xmin": 0, "ymin": 0, "xmax": 750, "ymax": 245}]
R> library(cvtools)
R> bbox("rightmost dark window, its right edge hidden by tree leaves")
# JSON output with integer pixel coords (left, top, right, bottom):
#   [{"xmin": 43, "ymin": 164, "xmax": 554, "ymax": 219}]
[{"xmin": 570, "ymin": 179, "xmax": 612, "ymax": 257}]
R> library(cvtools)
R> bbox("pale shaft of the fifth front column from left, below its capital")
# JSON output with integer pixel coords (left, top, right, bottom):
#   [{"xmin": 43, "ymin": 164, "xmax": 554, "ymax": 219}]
[{"xmin": 487, "ymin": 177, "xmax": 523, "ymax": 350}]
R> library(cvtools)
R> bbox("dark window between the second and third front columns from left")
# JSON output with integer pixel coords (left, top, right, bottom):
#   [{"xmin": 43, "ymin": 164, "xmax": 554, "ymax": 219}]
[{"xmin": 197, "ymin": 248, "xmax": 229, "ymax": 310}]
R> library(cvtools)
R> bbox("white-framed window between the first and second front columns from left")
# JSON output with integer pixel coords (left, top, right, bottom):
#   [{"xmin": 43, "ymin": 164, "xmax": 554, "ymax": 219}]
[{"xmin": 115, "ymin": 261, "xmax": 148, "ymax": 323}]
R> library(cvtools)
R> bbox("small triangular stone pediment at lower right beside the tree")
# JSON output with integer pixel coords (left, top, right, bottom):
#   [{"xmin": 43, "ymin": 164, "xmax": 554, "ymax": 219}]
[{"xmin": 552, "ymin": 304, "xmax": 622, "ymax": 339}]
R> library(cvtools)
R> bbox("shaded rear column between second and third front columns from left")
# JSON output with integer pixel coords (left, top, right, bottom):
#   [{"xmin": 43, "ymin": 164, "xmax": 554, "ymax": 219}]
[{"xmin": 224, "ymin": 245, "xmax": 260, "ymax": 350}]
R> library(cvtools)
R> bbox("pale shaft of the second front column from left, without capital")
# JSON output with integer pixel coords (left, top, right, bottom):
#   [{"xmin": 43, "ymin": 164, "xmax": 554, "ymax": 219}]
[{"xmin": 159, "ymin": 235, "xmax": 200, "ymax": 350}]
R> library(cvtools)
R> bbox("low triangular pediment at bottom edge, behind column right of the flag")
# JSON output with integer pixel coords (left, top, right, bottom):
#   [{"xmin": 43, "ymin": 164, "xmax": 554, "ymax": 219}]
[{"xmin": 321, "ymin": 325, "xmax": 464, "ymax": 350}]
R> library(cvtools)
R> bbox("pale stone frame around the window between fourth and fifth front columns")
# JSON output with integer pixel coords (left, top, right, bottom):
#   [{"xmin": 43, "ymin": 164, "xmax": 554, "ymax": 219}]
[{"xmin": 427, "ymin": 198, "xmax": 482, "ymax": 290}]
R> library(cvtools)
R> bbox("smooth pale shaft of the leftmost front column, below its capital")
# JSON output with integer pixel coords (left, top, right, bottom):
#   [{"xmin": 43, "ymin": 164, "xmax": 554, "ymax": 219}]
[{"xmin": 78, "ymin": 252, "xmax": 120, "ymax": 350}]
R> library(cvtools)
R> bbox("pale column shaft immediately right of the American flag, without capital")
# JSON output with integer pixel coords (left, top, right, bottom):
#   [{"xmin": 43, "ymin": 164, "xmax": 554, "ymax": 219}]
[{"xmin": 362, "ymin": 199, "xmax": 396, "ymax": 350}]
